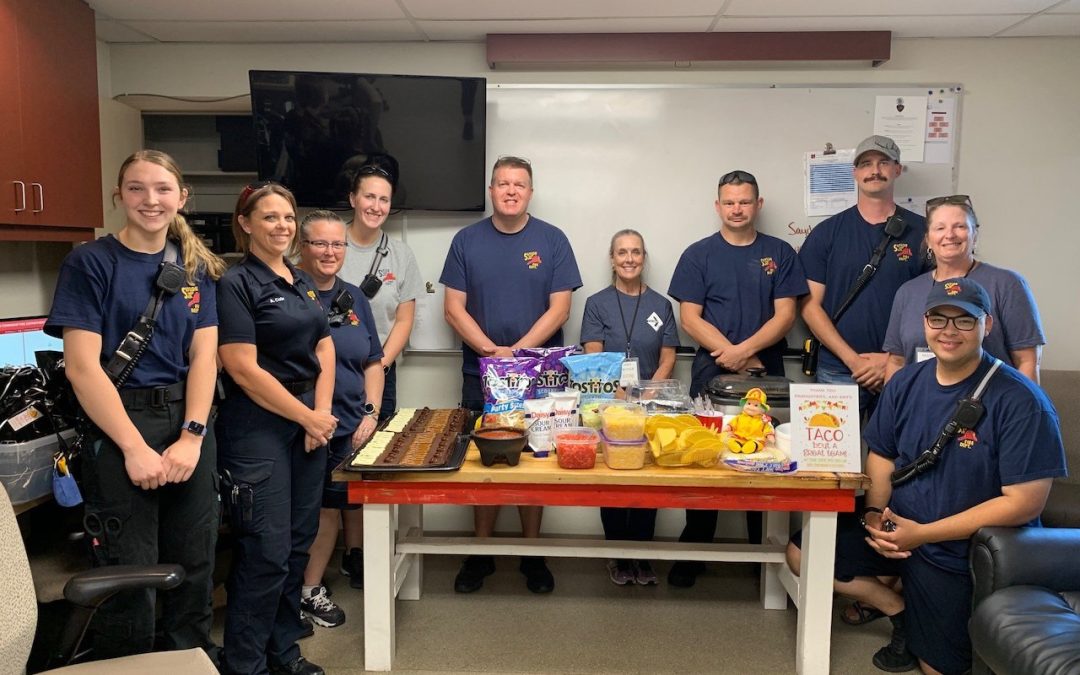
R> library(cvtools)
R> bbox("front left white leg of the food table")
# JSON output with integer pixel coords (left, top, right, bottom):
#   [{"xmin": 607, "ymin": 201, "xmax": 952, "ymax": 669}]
[{"xmin": 364, "ymin": 504, "xmax": 396, "ymax": 671}]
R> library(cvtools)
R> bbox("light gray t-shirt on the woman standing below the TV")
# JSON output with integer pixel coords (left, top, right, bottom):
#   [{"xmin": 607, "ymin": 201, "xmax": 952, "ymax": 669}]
[{"xmin": 338, "ymin": 230, "xmax": 423, "ymax": 343}]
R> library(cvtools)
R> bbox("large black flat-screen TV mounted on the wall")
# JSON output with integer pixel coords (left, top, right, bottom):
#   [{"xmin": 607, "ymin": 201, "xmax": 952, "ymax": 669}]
[{"xmin": 248, "ymin": 70, "xmax": 487, "ymax": 211}]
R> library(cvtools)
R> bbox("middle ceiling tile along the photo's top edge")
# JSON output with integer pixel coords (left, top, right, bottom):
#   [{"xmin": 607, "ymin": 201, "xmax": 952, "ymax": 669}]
[{"xmin": 402, "ymin": 0, "xmax": 724, "ymax": 21}]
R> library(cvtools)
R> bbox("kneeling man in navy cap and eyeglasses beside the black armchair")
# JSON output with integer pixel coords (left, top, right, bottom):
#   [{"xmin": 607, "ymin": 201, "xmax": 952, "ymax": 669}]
[{"xmin": 796, "ymin": 278, "xmax": 1066, "ymax": 673}]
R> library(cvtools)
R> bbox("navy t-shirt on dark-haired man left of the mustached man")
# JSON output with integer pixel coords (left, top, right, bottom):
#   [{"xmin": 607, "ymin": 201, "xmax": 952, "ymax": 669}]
[{"xmin": 667, "ymin": 232, "xmax": 809, "ymax": 365}]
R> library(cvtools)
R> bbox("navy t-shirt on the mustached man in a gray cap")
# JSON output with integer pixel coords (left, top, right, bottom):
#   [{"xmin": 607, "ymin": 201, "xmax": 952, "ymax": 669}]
[{"xmin": 799, "ymin": 206, "xmax": 927, "ymax": 370}]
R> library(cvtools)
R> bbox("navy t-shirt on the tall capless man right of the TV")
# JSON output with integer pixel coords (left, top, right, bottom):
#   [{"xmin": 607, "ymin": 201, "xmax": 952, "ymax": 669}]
[{"xmin": 438, "ymin": 216, "xmax": 581, "ymax": 375}]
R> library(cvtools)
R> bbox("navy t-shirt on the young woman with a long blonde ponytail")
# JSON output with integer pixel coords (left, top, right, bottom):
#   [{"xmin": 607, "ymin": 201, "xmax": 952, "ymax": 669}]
[{"xmin": 44, "ymin": 234, "xmax": 217, "ymax": 389}]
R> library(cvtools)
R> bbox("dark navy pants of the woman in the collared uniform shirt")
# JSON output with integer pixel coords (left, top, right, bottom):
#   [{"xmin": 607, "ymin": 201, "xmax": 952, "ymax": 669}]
[{"xmin": 217, "ymin": 391, "xmax": 326, "ymax": 674}]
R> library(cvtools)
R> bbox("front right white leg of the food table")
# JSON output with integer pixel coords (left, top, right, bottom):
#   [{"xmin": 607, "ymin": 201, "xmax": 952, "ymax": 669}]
[{"xmin": 795, "ymin": 511, "xmax": 836, "ymax": 675}]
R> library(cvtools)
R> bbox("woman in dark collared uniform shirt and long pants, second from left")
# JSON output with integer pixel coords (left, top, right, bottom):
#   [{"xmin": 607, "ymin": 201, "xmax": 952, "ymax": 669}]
[{"xmin": 215, "ymin": 183, "xmax": 338, "ymax": 675}]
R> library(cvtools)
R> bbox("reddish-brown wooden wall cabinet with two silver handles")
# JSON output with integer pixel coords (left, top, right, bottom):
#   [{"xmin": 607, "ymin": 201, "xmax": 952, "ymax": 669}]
[{"xmin": 0, "ymin": 0, "xmax": 103, "ymax": 241}]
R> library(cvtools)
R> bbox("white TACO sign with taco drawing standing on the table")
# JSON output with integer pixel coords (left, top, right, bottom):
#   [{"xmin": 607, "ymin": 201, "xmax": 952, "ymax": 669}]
[{"xmin": 791, "ymin": 383, "xmax": 862, "ymax": 473}]
